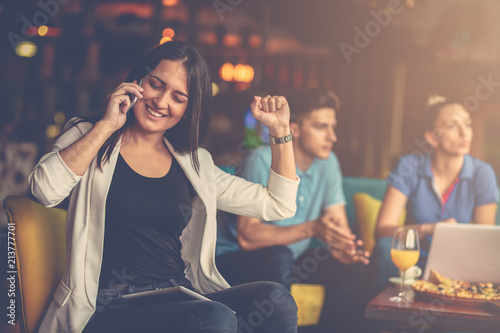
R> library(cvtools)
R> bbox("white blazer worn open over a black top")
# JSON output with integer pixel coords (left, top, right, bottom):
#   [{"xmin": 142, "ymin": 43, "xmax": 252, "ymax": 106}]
[{"xmin": 29, "ymin": 123, "xmax": 299, "ymax": 333}]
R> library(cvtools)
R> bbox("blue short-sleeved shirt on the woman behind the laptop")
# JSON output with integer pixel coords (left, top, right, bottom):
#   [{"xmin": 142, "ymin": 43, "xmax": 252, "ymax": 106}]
[{"xmin": 387, "ymin": 154, "xmax": 498, "ymax": 244}]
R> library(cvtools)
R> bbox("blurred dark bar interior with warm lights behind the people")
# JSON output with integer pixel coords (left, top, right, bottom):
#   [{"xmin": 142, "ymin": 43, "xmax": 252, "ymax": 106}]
[{"xmin": 0, "ymin": 0, "xmax": 500, "ymax": 332}]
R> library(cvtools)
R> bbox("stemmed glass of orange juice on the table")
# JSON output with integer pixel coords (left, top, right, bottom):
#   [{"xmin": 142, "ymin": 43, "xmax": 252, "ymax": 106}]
[{"xmin": 390, "ymin": 227, "xmax": 420, "ymax": 302}]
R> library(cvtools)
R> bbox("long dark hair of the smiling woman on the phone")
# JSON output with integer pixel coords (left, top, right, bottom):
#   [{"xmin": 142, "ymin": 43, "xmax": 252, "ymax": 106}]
[{"xmin": 66, "ymin": 41, "xmax": 212, "ymax": 174}]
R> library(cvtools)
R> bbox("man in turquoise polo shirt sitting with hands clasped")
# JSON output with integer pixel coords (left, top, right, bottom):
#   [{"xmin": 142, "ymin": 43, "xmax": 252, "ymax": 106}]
[{"xmin": 216, "ymin": 88, "xmax": 369, "ymax": 332}]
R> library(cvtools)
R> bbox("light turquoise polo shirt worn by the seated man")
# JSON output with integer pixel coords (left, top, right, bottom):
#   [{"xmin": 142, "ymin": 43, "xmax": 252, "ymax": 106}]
[{"xmin": 216, "ymin": 145, "xmax": 345, "ymax": 258}]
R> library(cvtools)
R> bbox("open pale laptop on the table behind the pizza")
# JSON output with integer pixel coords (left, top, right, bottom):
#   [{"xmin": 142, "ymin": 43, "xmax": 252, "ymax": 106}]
[{"xmin": 423, "ymin": 223, "xmax": 500, "ymax": 284}]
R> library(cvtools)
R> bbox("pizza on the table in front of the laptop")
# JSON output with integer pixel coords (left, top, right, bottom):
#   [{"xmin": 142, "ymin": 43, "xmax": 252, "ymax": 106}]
[{"xmin": 412, "ymin": 270, "xmax": 500, "ymax": 300}]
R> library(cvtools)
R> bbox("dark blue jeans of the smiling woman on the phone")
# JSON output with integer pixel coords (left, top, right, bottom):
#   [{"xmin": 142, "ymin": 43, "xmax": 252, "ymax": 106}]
[{"xmin": 84, "ymin": 282, "xmax": 297, "ymax": 333}]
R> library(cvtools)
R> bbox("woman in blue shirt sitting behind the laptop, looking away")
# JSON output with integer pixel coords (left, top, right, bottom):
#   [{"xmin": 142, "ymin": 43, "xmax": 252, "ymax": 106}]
[{"xmin": 368, "ymin": 96, "xmax": 498, "ymax": 294}]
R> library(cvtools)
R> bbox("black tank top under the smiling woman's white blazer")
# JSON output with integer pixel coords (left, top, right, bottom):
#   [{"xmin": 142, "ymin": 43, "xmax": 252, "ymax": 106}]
[{"xmin": 99, "ymin": 154, "xmax": 196, "ymax": 289}]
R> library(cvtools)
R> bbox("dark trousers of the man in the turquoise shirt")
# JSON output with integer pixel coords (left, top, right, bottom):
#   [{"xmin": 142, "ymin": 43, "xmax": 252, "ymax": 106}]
[{"xmin": 216, "ymin": 245, "xmax": 367, "ymax": 333}]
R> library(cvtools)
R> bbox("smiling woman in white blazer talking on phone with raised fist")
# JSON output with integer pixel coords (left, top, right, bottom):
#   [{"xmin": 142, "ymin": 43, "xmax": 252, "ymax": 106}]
[{"xmin": 30, "ymin": 42, "xmax": 299, "ymax": 333}]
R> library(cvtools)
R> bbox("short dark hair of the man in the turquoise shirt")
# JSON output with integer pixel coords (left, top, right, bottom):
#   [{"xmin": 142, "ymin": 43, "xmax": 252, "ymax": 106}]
[{"xmin": 287, "ymin": 88, "xmax": 340, "ymax": 122}]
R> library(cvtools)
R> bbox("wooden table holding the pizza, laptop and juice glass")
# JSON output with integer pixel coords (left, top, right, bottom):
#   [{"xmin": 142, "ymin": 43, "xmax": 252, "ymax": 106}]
[{"xmin": 365, "ymin": 286, "xmax": 500, "ymax": 332}]
